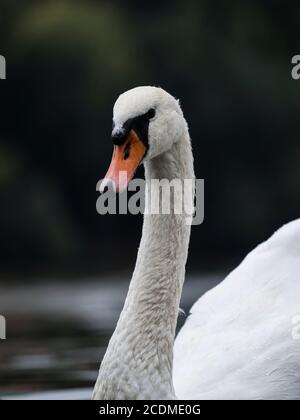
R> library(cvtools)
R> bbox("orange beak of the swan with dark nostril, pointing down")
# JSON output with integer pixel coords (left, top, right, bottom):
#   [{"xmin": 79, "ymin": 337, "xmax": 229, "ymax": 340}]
[{"xmin": 100, "ymin": 130, "xmax": 146, "ymax": 193}]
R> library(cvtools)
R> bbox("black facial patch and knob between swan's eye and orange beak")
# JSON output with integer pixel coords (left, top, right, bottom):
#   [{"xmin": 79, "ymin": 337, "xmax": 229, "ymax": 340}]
[{"xmin": 112, "ymin": 108, "xmax": 156, "ymax": 149}]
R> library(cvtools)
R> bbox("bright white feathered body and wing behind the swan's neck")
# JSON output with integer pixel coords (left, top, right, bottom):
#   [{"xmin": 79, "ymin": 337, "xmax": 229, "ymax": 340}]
[{"xmin": 173, "ymin": 219, "xmax": 300, "ymax": 400}]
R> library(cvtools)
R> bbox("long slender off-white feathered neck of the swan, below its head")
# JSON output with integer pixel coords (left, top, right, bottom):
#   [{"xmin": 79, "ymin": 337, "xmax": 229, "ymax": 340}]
[{"xmin": 94, "ymin": 129, "xmax": 194, "ymax": 400}]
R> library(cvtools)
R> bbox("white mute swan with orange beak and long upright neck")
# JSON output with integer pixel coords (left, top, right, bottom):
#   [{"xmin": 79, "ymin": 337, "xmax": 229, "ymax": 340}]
[{"xmin": 93, "ymin": 87, "xmax": 300, "ymax": 400}]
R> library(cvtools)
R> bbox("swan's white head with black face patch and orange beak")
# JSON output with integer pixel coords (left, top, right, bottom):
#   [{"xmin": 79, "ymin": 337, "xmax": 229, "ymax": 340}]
[{"xmin": 101, "ymin": 86, "xmax": 186, "ymax": 192}]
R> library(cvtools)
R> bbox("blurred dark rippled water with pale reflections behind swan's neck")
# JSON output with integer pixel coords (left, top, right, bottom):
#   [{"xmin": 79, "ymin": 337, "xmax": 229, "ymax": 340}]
[{"xmin": 0, "ymin": 276, "xmax": 222, "ymax": 396}]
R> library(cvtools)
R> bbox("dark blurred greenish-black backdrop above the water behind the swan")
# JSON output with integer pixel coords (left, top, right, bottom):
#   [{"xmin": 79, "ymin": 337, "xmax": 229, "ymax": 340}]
[{"xmin": 0, "ymin": 0, "xmax": 300, "ymax": 398}]
